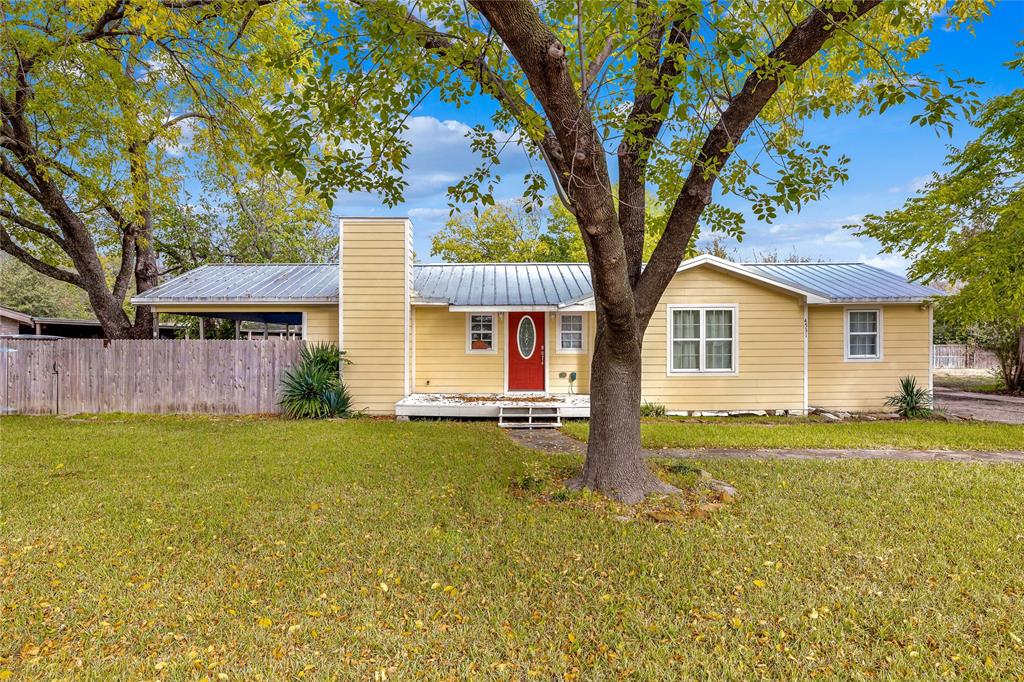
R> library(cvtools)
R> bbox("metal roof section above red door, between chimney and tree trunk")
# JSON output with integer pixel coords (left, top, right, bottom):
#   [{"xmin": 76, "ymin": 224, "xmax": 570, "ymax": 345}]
[{"xmin": 413, "ymin": 263, "xmax": 593, "ymax": 306}]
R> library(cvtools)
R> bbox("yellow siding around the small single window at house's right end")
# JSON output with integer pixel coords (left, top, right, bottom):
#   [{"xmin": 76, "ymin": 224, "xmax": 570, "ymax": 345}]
[{"xmin": 808, "ymin": 304, "xmax": 931, "ymax": 412}]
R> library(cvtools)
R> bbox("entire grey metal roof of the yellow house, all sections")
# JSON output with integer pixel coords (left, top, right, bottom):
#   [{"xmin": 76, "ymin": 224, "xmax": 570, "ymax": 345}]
[{"xmin": 132, "ymin": 256, "xmax": 942, "ymax": 307}]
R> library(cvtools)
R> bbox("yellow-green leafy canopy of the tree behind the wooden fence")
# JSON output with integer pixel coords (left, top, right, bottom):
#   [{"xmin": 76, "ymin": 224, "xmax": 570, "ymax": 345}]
[{"xmin": 0, "ymin": 0, "xmax": 326, "ymax": 337}]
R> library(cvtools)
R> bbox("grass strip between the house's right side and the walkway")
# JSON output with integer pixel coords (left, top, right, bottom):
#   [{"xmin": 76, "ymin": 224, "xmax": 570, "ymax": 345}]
[{"xmin": 563, "ymin": 417, "xmax": 1024, "ymax": 451}]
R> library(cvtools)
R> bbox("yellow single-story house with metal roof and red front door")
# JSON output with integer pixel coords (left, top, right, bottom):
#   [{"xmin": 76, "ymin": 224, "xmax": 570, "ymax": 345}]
[{"xmin": 132, "ymin": 218, "xmax": 940, "ymax": 416}]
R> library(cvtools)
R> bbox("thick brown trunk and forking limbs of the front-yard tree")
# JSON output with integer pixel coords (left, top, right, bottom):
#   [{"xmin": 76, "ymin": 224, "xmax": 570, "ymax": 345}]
[{"xmin": 460, "ymin": 0, "xmax": 882, "ymax": 503}]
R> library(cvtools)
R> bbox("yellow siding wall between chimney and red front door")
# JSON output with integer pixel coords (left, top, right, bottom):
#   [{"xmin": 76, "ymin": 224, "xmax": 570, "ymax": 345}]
[{"xmin": 414, "ymin": 306, "xmax": 505, "ymax": 393}]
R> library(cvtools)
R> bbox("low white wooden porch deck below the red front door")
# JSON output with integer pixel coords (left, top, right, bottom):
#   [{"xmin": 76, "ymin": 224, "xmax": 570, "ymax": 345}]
[{"xmin": 394, "ymin": 393, "xmax": 590, "ymax": 419}]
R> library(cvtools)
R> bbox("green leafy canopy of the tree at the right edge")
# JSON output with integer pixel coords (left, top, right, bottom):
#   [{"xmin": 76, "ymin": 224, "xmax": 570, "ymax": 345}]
[{"xmin": 857, "ymin": 62, "xmax": 1024, "ymax": 390}]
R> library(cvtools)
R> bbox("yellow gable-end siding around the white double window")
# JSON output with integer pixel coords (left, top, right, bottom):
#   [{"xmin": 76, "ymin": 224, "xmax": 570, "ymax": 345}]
[{"xmin": 643, "ymin": 266, "xmax": 804, "ymax": 411}]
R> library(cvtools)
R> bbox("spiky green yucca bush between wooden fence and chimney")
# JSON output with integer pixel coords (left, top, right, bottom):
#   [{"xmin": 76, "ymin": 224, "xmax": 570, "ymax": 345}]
[{"xmin": 281, "ymin": 343, "xmax": 352, "ymax": 419}]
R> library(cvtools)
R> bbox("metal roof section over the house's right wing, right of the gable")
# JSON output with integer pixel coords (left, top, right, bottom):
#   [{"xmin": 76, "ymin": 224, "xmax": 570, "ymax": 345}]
[{"xmin": 742, "ymin": 263, "xmax": 942, "ymax": 302}]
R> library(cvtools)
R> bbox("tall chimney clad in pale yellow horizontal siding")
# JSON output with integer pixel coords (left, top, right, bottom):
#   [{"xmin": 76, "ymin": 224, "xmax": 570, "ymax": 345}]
[{"xmin": 340, "ymin": 218, "xmax": 412, "ymax": 415}]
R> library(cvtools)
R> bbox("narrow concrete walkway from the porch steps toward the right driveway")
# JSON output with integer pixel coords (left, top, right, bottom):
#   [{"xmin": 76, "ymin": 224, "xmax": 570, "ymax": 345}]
[{"xmin": 508, "ymin": 429, "xmax": 1024, "ymax": 464}]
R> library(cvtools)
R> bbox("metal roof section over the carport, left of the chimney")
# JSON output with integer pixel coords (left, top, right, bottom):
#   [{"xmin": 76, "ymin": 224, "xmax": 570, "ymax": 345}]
[{"xmin": 131, "ymin": 263, "xmax": 338, "ymax": 305}]
